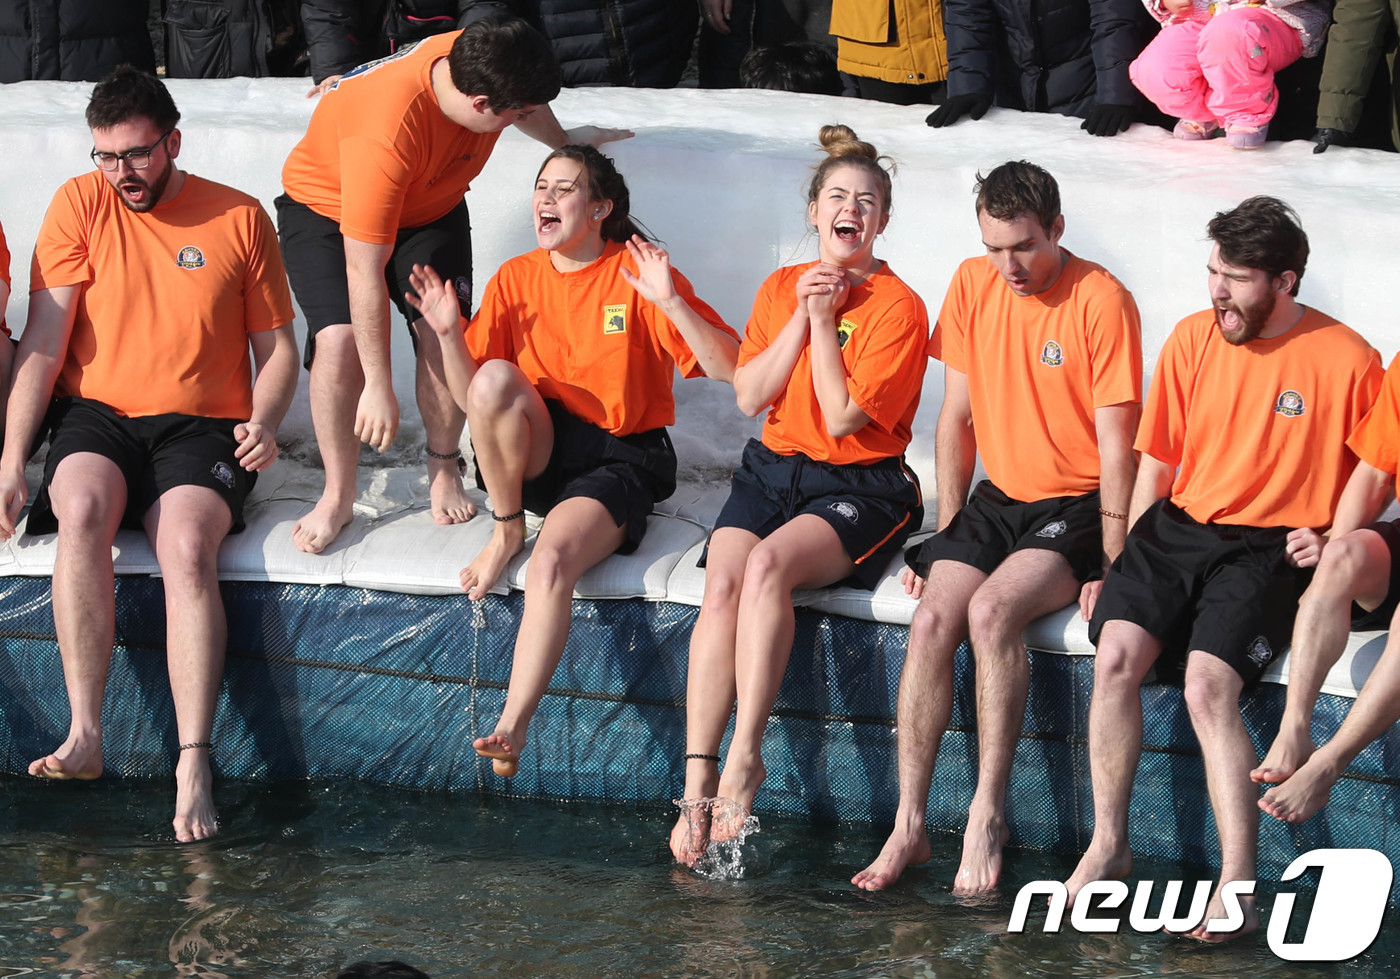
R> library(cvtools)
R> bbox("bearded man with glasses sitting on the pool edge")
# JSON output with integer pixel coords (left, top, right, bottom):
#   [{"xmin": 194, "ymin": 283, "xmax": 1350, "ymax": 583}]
[{"xmin": 0, "ymin": 67, "xmax": 297, "ymax": 840}]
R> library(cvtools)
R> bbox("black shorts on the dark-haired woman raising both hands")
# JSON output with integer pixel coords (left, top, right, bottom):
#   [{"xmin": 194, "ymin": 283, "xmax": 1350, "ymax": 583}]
[{"xmin": 473, "ymin": 399, "xmax": 676, "ymax": 555}]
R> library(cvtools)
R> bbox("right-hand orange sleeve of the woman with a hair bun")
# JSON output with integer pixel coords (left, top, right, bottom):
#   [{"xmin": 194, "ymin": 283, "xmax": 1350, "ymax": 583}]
[{"xmin": 843, "ymin": 287, "xmax": 928, "ymax": 431}]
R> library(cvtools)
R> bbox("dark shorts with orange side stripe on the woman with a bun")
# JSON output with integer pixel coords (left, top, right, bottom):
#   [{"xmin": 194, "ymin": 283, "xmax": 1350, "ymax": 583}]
[{"xmin": 700, "ymin": 438, "xmax": 924, "ymax": 588}]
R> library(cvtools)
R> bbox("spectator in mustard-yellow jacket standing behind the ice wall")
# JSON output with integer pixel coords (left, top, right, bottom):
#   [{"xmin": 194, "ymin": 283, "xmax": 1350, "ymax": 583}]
[{"xmin": 832, "ymin": 0, "xmax": 948, "ymax": 105}]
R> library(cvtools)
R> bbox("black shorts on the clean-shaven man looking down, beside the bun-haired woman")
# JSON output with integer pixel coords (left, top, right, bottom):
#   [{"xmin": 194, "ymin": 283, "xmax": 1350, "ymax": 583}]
[{"xmin": 904, "ymin": 479, "xmax": 1103, "ymax": 584}]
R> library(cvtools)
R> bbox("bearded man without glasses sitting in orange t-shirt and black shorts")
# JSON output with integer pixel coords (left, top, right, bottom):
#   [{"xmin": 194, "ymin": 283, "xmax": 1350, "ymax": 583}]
[{"xmin": 1068, "ymin": 197, "xmax": 1382, "ymax": 941}]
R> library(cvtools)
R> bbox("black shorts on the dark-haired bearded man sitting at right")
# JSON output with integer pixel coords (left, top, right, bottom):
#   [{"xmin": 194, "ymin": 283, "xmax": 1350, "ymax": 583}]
[{"xmin": 1089, "ymin": 500, "xmax": 1312, "ymax": 683}]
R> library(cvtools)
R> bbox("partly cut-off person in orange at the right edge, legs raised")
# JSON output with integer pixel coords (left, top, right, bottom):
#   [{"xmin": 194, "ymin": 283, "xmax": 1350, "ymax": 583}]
[{"xmin": 1249, "ymin": 357, "xmax": 1400, "ymax": 822}]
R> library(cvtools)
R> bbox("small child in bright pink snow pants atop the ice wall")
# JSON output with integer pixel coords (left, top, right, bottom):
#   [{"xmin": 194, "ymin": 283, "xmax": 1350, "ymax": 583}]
[{"xmin": 1128, "ymin": 0, "xmax": 1331, "ymax": 150}]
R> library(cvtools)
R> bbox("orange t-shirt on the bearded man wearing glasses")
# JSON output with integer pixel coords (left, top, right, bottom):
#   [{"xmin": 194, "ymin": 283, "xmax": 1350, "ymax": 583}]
[{"xmin": 29, "ymin": 171, "xmax": 291, "ymax": 419}]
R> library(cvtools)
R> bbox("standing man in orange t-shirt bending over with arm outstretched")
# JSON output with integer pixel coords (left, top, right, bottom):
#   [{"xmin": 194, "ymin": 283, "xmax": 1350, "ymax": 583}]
[{"xmin": 276, "ymin": 17, "xmax": 631, "ymax": 553}]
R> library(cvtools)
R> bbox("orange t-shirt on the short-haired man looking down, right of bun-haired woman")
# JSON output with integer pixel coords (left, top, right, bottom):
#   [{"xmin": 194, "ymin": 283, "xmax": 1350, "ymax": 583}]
[{"xmin": 928, "ymin": 252, "xmax": 1142, "ymax": 503}]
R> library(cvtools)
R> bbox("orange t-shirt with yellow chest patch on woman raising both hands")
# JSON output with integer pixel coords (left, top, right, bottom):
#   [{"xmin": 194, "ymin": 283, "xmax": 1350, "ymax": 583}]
[{"xmin": 466, "ymin": 241, "xmax": 738, "ymax": 436}]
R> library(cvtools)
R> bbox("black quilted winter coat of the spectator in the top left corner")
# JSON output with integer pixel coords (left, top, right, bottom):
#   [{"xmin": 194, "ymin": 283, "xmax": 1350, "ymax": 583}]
[{"xmin": 0, "ymin": 0, "xmax": 155, "ymax": 81}]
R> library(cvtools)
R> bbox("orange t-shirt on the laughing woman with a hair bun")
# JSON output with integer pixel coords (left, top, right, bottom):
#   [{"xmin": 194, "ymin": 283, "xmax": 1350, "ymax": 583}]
[{"xmin": 739, "ymin": 262, "xmax": 928, "ymax": 465}]
